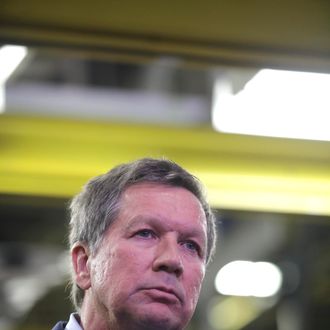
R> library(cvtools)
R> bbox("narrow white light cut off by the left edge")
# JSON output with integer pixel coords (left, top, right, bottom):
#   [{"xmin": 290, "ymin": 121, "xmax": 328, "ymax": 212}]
[{"xmin": 0, "ymin": 45, "xmax": 27, "ymax": 112}]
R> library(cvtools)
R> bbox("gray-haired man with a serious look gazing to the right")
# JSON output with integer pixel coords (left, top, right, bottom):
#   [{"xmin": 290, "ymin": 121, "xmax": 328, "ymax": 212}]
[{"xmin": 53, "ymin": 158, "xmax": 216, "ymax": 330}]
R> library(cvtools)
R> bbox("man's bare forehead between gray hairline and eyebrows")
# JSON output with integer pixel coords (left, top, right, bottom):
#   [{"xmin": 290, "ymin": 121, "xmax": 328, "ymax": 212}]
[{"xmin": 118, "ymin": 183, "xmax": 206, "ymax": 231}]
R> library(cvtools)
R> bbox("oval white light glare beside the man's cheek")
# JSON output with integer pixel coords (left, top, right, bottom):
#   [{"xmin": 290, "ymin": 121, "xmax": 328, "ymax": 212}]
[{"xmin": 215, "ymin": 260, "xmax": 282, "ymax": 297}]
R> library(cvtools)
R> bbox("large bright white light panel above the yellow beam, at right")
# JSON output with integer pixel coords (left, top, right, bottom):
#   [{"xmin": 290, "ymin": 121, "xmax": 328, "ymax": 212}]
[{"xmin": 212, "ymin": 69, "xmax": 330, "ymax": 141}]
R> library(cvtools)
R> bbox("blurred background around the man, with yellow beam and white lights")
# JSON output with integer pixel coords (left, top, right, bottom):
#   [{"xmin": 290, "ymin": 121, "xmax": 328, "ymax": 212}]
[{"xmin": 0, "ymin": 0, "xmax": 330, "ymax": 330}]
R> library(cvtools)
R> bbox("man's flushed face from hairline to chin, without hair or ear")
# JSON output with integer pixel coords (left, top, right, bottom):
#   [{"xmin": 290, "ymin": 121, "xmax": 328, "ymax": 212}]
[{"xmin": 89, "ymin": 183, "xmax": 206, "ymax": 329}]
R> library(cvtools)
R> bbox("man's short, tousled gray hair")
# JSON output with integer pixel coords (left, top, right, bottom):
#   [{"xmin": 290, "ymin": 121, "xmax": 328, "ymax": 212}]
[{"xmin": 69, "ymin": 158, "xmax": 216, "ymax": 310}]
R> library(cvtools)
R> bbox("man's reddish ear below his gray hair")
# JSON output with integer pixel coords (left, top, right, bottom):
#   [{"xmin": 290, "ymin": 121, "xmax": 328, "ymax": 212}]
[{"xmin": 71, "ymin": 242, "xmax": 91, "ymax": 290}]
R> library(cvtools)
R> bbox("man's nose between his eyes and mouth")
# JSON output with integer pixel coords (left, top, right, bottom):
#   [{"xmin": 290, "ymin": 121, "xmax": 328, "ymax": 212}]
[{"xmin": 153, "ymin": 238, "xmax": 183, "ymax": 277}]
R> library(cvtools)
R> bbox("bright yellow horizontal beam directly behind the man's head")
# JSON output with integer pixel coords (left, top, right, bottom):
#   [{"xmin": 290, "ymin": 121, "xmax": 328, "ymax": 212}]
[{"xmin": 0, "ymin": 115, "xmax": 330, "ymax": 215}]
